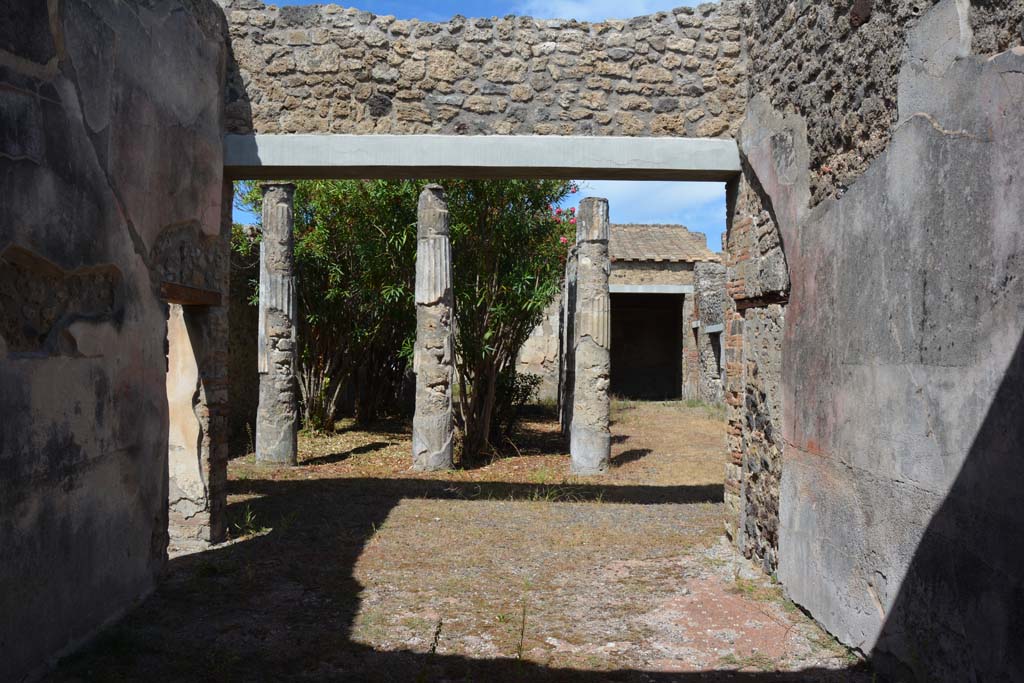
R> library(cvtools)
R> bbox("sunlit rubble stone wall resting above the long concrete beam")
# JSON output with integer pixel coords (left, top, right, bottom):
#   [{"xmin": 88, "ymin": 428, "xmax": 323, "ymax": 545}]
[{"xmin": 218, "ymin": 0, "xmax": 746, "ymax": 137}]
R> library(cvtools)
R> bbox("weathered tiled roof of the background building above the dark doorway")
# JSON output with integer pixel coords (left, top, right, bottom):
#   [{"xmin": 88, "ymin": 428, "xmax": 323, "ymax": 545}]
[{"xmin": 608, "ymin": 224, "xmax": 720, "ymax": 263}]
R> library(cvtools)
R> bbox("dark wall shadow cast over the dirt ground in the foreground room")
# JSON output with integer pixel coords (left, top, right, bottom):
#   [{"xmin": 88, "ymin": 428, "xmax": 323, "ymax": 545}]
[{"xmin": 51, "ymin": 470, "xmax": 872, "ymax": 683}]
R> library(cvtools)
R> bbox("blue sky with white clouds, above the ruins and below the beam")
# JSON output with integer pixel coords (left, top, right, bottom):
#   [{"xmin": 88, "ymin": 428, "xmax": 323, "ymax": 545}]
[{"xmin": 236, "ymin": 0, "xmax": 725, "ymax": 251}]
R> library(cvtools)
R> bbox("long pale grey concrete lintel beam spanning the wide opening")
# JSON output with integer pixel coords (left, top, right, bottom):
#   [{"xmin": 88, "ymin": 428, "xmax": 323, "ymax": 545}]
[{"xmin": 224, "ymin": 134, "xmax": 740, "ymax": 182}]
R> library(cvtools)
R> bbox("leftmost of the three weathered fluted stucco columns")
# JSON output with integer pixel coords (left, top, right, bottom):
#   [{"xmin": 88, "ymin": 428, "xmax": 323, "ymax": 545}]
[{"xmin": 256, "ymin": 183, "xmax": 299, "ymax": 465}]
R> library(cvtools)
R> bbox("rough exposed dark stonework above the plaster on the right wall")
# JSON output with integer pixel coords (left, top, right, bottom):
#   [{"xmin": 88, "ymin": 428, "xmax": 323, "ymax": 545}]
[{"xmin": 746, "ymin": 0, "xmax": 1024, "ymax": 204}]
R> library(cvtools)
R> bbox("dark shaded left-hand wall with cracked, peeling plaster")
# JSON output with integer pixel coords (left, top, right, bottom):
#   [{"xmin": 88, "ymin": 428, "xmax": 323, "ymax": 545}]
[{"xmin": 0, "ymin": 0, "xmax": 226, "ymax": 680}]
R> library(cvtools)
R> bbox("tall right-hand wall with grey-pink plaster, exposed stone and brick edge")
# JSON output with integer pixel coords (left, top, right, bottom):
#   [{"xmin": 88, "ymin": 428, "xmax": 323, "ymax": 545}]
[{"xmin": 741, "ymin": 0, "xmax": 1024, "ymax": 680}]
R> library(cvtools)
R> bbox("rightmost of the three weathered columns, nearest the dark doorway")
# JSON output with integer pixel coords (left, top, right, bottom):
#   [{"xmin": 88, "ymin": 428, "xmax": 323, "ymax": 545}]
[{"xmin": 569, "ymin": 197, "xmax": 611, "ymax": 474}]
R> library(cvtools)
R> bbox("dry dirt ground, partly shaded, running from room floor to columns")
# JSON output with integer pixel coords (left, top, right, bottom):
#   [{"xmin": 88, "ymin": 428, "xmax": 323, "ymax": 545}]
[{"xmin": 51, "ymin": 402, "xmax": 870, "ymax": 682}]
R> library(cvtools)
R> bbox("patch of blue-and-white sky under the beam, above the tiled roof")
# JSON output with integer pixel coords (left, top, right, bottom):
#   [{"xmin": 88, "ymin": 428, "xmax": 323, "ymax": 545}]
[{"xmin": 564, "ymin": 180, "xmax": 725, "ymax": 251}]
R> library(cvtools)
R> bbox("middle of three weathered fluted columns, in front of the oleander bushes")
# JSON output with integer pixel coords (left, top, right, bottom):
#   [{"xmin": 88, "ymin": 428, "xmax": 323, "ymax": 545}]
[{"xmin": 413, "ymin": 185, "xmax": 455, "ymax": 472}]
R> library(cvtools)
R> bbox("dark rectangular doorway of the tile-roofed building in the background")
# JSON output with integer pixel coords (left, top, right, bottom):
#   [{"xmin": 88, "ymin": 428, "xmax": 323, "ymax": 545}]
[{"xmin": 611, "ymin": 294, "xmax": 683, "ymax": 400}]
